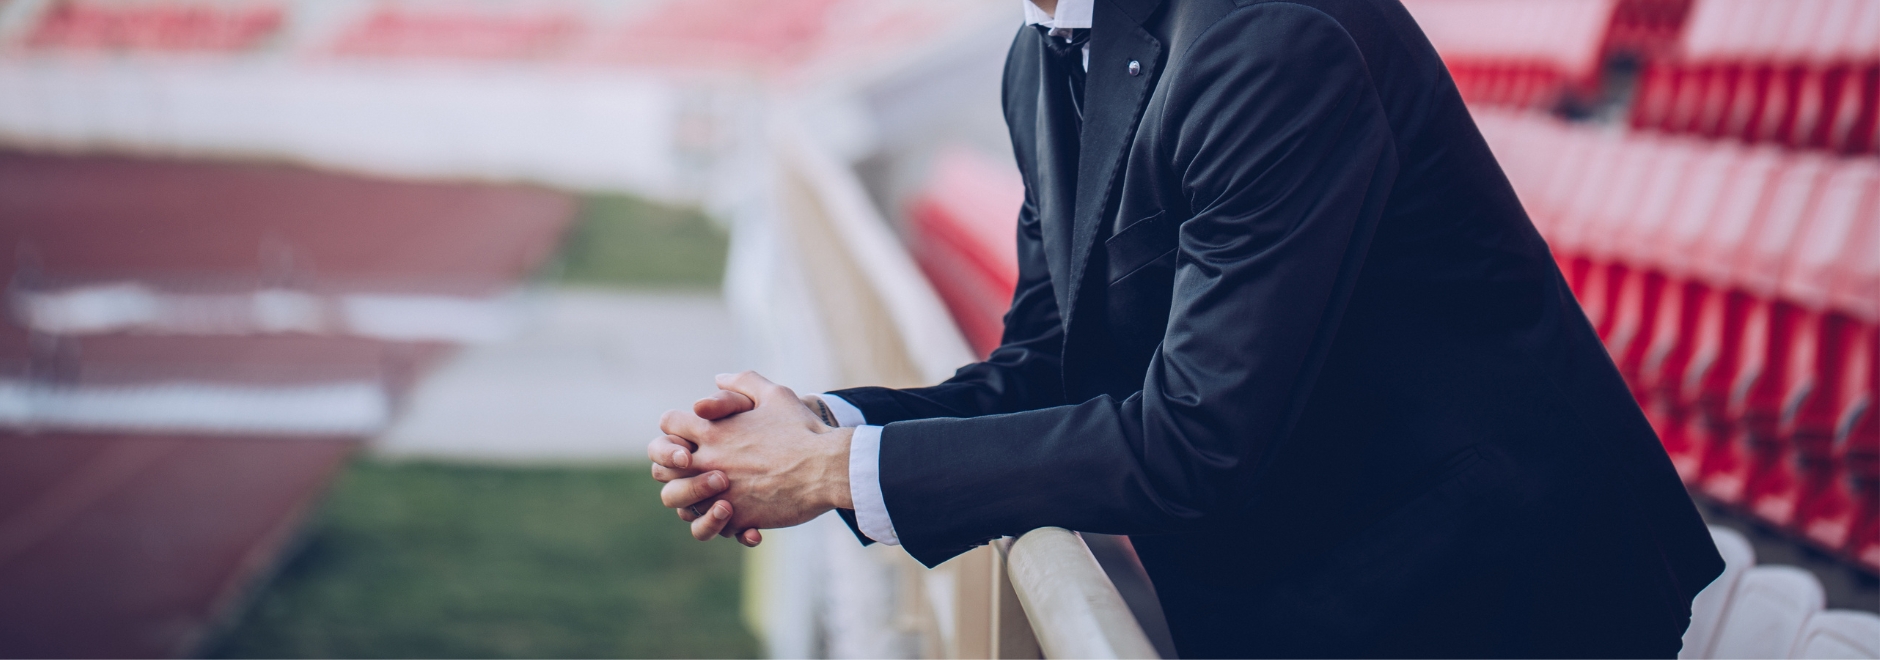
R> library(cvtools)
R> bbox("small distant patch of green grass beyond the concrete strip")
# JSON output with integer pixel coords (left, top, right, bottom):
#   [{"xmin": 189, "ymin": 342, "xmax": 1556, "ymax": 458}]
[{"xmin": 549, "ymin": 196, "xmax": 729, "ymax": 288}]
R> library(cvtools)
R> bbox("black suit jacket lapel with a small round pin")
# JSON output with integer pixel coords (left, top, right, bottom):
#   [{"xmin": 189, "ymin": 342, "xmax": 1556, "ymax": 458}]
[{"xmin": 1053, "ymin": 0, "xmax": 1162, "ymax": 331}]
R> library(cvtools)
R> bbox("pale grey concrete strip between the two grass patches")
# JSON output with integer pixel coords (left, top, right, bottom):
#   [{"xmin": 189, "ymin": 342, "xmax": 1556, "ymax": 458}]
[{"xmin": 372, "ymin": 290, "xmax": 741, "ymax": 463}]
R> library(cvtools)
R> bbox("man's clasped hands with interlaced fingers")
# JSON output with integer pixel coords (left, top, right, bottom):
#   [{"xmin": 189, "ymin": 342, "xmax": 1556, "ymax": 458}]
[{"xmin": 647, "ymin": 370, "xmax": 854, "ymax": 545}]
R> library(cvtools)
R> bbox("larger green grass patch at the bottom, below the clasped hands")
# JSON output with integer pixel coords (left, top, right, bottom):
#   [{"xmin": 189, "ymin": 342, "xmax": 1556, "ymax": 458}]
[{"xmin": 209, "ymin": 461, "xmax": 758, "ymax": 658}]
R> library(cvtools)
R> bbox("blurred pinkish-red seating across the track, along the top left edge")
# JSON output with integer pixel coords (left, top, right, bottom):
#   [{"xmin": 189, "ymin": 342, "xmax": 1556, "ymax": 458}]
[{"xmin": 17, "ymin": 0, "xmax": 879, "ymax": 70}]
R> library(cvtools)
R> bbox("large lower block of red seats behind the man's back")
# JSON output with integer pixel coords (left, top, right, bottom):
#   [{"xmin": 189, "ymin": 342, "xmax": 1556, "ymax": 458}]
[{"xmin": 1476, "ymin": 109, "xmax": 1880, "ymax": 570}]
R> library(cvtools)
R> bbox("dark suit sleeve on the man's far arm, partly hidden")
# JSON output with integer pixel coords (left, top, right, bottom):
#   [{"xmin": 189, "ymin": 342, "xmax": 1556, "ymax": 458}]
[{"xmin": 835, "ymin": 30, "xmax": 1064, "ymax": 425}]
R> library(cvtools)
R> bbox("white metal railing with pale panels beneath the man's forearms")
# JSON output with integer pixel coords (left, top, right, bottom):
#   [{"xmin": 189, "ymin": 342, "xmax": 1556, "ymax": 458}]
[{"xmin": 728, "ymin": 110, "xmax": 1156, "ymax": 658}]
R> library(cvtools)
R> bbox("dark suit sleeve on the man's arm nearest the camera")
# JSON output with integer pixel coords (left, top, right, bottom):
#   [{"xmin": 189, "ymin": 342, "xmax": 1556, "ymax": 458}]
[{"xmin": 870, "ymin": 4, "xmax": 1397, "ymax": 566}]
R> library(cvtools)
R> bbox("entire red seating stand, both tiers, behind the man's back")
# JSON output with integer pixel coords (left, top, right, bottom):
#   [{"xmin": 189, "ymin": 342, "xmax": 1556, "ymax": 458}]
[{"xmin": 1368, "ymin": 0, "xmax": 1880, "ymax": 572}]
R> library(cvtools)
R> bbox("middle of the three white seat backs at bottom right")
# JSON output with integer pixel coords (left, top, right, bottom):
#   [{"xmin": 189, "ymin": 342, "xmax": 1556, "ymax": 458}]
[{"xmin": 1711, "ymin": 566, "xmax": 1824, "ymax": 658}]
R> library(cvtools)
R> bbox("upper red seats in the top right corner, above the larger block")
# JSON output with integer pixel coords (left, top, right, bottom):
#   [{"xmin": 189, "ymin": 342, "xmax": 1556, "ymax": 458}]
[{"xmin": 1406, "ymin": 0, "xmax": 1880, "ymax": 154}]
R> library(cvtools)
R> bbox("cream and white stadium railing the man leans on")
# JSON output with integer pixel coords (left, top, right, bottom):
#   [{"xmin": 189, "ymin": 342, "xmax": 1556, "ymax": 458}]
[{"xmin": 728, "ymin": 122, "xmax": 1158, "ymax": 658}]
